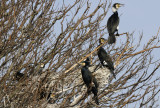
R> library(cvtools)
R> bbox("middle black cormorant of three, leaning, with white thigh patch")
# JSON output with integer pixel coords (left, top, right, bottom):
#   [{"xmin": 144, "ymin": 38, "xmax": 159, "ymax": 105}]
[{"xmin": 98, "ymin": 38, "xmax": 116, "ymax": 79}]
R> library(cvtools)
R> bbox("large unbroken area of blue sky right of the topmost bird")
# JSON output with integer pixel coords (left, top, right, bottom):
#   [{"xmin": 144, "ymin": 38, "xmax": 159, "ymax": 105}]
[{"xmin": 116, "ymin": 0, "xmax": 160, "ymax": 42}]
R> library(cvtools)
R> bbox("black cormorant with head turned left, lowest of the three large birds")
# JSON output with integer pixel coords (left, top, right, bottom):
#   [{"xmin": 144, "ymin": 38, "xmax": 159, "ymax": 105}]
[{"xmin": 81, "ymin": 58, "xmax": 99, "ymax": 105}]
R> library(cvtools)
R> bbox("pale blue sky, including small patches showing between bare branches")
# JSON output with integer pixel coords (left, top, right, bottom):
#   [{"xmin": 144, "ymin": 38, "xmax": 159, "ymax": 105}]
[{"xmin": 52, "ymin": 0, "xmax": 160, "ymax": 106}]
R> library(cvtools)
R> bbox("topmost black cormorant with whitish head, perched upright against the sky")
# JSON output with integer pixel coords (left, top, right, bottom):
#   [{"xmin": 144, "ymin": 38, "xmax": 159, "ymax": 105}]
[{"xmin": 107, "ymin": 3, "xmax": 123, "ymax": 44}]
